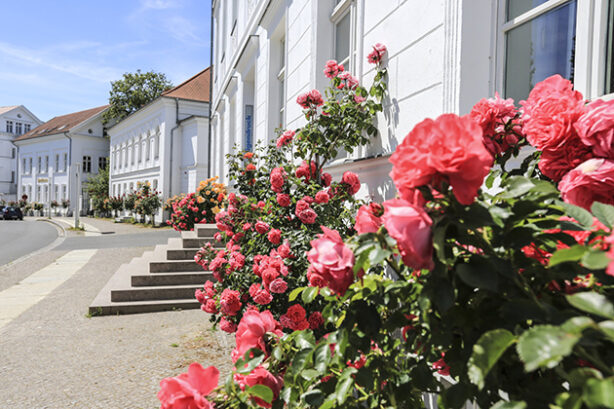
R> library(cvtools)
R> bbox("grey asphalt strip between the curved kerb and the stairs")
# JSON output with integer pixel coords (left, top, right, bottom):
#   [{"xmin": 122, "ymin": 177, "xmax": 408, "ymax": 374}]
[{"xmin": 55, "ymin": 229, "xmax": 180, "ymax": 250}]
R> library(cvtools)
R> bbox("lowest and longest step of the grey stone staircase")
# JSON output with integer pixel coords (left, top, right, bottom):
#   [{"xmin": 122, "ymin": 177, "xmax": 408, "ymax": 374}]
[{"xmin": 88, "ymin": 297, "xmax": 200, "ymax": 316}]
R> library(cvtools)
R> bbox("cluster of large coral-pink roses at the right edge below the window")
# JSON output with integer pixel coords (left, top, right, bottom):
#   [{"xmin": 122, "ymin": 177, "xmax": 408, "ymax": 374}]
[{"xmin": 520, "ymin": 75, "xmax": 614, "ymax": 210}]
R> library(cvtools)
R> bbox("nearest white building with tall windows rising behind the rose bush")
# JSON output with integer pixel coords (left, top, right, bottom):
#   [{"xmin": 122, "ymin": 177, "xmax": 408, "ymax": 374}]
[{"xmin": 211, "ymin": 0, "xmax": 614, "ymax": 199}]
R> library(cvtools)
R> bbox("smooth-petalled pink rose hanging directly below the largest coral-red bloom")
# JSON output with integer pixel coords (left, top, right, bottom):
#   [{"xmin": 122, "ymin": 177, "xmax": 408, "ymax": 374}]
[{"xmin": 382, "ymin": 199, "xmax": 434, "ymax": 270}]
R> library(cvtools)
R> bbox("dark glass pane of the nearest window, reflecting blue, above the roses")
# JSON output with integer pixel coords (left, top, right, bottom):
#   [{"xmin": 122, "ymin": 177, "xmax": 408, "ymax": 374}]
[{"xmin": 503, "ymin": 0, "xmax": 577, "ymax": 101}]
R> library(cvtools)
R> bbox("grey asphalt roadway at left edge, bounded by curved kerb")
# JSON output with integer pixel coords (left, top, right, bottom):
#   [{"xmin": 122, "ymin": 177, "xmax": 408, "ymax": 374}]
[{"xmin": 0, "ymin": 220, "xmax": 58, "ymax": 266}]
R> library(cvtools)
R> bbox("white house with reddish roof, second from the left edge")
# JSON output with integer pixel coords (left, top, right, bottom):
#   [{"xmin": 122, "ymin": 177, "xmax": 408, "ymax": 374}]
[{"xmin": 15, "ymin": 105, "xmax": 109, "ymax": 213}]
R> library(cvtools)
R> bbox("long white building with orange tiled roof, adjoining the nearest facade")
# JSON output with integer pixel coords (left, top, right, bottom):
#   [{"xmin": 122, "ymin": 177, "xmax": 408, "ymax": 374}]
[{"xmin": 108, "ymin": 68, "xmax": 211, "ymax": 217}]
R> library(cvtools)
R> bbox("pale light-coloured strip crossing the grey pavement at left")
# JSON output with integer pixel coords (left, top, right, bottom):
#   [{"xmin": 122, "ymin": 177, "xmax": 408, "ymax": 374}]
[{"xmin": 0, "ymin": 249, "xmax": 97, "ymax": 328}]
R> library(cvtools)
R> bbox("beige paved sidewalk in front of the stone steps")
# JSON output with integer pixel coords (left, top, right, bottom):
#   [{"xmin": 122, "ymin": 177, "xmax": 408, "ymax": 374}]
[{"xmin": 0, "ymin": 247, "xmax": 233, "ymax": 409}]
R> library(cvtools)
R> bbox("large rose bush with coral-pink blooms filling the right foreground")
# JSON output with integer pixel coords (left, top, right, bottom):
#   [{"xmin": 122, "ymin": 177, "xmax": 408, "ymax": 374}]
[{"xmin": 159, "ymin": 56, "xmax": 614, "ymax": 409}]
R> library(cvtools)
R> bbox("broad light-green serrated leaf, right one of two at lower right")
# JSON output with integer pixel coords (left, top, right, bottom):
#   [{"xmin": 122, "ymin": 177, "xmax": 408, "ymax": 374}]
[{"xmin": 516, "ymin": 325, "xmax": 581, "ymax": 372}]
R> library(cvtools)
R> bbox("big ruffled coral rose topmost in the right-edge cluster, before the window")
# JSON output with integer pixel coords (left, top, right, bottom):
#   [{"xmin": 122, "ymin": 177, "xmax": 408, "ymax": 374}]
[{"xmin": 520, "ymin": 74, "xmax": 586, "ymax": 150}]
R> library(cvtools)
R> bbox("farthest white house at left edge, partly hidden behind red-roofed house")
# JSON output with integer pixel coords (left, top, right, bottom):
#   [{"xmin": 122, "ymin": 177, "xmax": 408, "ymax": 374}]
[{"xmin": 0, "ymin": 105, "xmax": 42, "ymax": 202}]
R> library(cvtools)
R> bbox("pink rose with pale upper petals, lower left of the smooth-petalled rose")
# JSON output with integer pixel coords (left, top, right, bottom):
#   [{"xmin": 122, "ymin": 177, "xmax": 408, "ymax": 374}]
[{"xmin": 307, "ymin": 226, "xmax": 354, "ymax": 295}]
